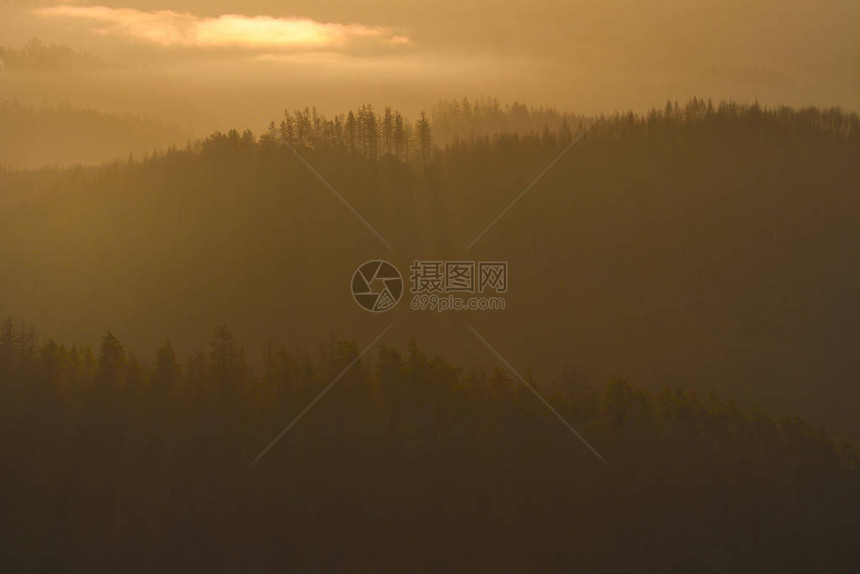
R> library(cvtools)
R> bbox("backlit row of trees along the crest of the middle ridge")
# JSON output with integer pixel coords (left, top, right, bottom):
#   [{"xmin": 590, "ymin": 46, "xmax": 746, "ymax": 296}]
[{"xmin": 232, "ymin": 98, "xmax": 860, "ymax": 170}]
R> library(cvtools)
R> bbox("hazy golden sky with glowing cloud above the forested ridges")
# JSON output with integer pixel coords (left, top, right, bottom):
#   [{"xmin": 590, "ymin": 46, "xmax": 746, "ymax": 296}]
[{"xmin": 0, "ymin": 0, "xmax": 860, "ymax": 132}]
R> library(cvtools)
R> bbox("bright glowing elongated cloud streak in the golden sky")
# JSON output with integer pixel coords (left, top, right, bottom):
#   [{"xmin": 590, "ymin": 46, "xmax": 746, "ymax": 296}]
[{"xmin": 35, "ymin": 5, "xmax": 409, "ymax": 49}]
